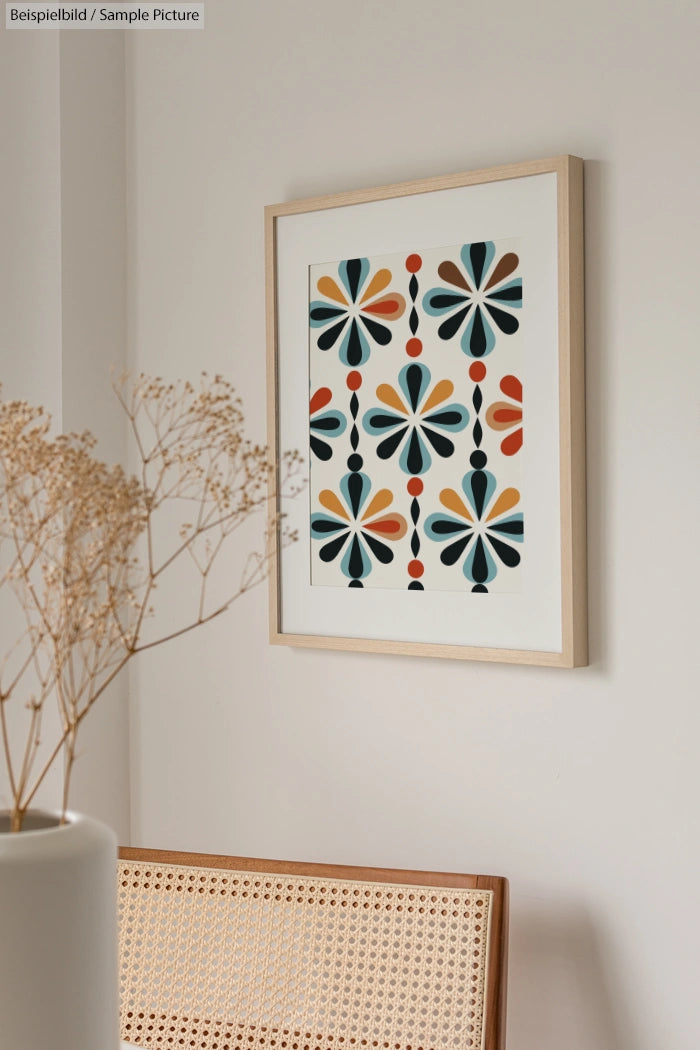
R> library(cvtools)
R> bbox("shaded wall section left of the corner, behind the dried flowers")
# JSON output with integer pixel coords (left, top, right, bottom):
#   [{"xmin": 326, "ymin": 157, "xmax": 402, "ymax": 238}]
[{"xmin": 0, "ymin": 29, "xmax": 129, "ymax": 839}]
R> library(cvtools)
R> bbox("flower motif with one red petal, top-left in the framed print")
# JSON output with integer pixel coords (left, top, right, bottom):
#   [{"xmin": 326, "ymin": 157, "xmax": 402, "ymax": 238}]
[{"xmin": 309, "ymin": 258, "xmax": 406, "ymax": 369}]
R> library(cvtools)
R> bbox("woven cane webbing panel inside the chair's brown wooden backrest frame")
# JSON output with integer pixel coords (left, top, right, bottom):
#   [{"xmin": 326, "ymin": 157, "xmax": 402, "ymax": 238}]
[{"xmin": 119, "ymin": 861, "xmax": 491, "ymax": 1050}]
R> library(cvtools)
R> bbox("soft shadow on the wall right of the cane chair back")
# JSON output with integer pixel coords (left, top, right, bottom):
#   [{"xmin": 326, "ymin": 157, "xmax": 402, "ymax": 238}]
[{"xmin": 507, "ymin": 902, "xmax": 636, "ymax": 1050}]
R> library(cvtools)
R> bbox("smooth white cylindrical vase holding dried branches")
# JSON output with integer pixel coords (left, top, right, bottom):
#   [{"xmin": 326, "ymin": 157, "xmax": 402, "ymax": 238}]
[{"xmin": 0, "ymin": 812, "xmax": 119, "ymax": 1050}]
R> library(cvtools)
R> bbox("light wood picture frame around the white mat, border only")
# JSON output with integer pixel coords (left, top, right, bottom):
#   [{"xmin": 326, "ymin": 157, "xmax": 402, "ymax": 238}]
[{"xmin": 266, "ymin": 155, "xmax": 588, "ymax": 668}]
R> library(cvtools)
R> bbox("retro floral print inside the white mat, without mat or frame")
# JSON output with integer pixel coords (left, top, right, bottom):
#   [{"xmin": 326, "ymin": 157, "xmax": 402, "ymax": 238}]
[{"xmin": 309, "ymin": 240, "xmax": 527, "ymax": 594}]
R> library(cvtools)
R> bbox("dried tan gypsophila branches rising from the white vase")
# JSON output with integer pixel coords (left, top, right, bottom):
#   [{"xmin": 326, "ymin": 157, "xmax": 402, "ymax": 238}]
[{"xmin": 0, "ymin": 376, "xmax": 303, "ymax": 830}]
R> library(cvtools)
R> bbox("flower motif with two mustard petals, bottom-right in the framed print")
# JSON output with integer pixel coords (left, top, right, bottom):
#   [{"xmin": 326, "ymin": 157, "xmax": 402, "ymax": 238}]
[{"xmin": 425, "ymin": 469, "xmax": 524, "ymax": 585}]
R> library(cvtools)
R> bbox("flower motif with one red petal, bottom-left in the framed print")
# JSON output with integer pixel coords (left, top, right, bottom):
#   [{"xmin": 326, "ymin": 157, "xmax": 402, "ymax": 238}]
[{"xmin": 311, "ymin": 471, "xmax": 408, "ymax": 581}]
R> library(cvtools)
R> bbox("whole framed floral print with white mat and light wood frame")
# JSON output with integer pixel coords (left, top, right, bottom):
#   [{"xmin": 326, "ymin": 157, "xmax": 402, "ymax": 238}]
[{"xmin": 266, "ymin": 156, "xmax": 587, "ymax": 667}]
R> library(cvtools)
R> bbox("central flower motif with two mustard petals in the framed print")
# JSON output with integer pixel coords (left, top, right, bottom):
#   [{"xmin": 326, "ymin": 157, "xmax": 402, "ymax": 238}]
[{"xmin": 362, "ymin": 363, "xmax": 469, "ymax": 475}]
